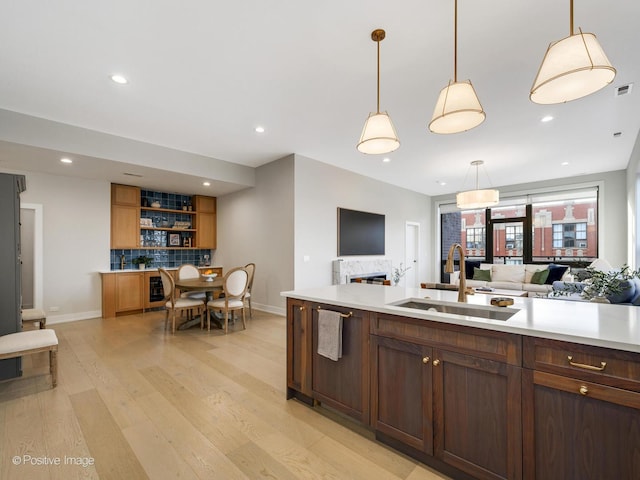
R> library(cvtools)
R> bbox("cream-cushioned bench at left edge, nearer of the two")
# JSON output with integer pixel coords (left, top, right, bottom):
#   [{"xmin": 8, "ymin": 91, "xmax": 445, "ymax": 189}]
[{"xmin": 0, "ymin": 329, "xmax": 58, "ymax": 387}]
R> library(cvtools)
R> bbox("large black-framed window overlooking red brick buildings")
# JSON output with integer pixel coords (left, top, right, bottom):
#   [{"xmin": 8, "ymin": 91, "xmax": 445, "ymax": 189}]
[{"xmin": 440, "ymin": 186, "xmax": 598, "ymax": 282}]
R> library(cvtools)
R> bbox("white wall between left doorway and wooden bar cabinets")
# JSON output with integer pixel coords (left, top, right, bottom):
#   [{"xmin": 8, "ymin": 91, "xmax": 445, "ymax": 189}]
[{"xmin": 0, "ymin": 171, "xmax": 111, "ymax": 323}]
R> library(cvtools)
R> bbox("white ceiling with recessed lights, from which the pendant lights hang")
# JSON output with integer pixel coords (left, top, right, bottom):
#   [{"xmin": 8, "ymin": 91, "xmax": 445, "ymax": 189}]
[{"xmin": 0, "ymin": 0, "xmax": 640, "ymax": 195}]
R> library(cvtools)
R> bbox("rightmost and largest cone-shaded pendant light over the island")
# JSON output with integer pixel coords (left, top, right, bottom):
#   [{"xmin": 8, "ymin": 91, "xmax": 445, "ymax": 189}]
[{"xmin": 529, "ymin": 0, "xmax": 616, "ymax": 105}]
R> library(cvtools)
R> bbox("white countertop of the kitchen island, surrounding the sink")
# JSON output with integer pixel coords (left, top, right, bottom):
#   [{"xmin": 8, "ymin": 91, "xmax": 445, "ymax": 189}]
[{"xmin": 281, "ymin": 283, "xmax": 640, "ymax": 353}]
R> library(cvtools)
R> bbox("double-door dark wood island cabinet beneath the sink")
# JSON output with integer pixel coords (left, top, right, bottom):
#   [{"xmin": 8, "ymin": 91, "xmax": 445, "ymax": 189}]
[{"xmin": 371, "ymin": 315, "xmax": 522, "ymax": 480}]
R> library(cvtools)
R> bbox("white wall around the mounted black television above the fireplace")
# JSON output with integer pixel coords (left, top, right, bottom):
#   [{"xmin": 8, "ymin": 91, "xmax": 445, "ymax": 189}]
[{"xmin": 294, "ymin": 155, "xmax": 432, "ymax": 289}]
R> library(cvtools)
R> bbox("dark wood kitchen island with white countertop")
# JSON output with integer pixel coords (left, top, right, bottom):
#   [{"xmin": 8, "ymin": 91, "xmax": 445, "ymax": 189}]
[{"xmin": 283, "ymin": 284, "xmax": 640, "ymax": 480}]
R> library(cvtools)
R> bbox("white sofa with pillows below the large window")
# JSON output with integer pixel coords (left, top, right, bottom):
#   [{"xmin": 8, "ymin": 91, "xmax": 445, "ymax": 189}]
[{"xmin": 449, "ymin": 263, "xmax": 573, "ymax": 297}]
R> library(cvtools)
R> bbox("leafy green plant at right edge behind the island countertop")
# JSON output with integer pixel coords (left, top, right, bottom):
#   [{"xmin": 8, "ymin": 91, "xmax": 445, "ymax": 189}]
[{"xmin": 553, "ymin": 264, "xmax": 640, "ymax": 300}]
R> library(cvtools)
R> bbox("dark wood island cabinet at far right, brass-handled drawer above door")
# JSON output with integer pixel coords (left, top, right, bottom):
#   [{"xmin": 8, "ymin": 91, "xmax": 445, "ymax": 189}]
[{"xmin": 523, "ymin": 338, "xmax": 640, "ymax": 480}]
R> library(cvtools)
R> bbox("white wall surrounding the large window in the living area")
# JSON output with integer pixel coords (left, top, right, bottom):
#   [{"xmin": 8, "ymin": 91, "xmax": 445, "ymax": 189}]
[{"xmin": 432, "ymin": 170, "xmax": 629, "ymax": 272}]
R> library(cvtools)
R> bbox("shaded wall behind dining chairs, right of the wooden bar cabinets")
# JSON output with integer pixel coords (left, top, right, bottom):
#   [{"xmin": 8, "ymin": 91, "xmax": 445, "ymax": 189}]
[{"xmin": 213, "ymin": 155, "xmax": 294, "ymax": 314}]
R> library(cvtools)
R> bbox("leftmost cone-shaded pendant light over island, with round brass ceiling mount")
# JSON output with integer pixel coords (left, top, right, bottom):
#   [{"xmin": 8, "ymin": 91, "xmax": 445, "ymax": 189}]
[{"xmin": 356, "ymin": 29, "xmax": 400, "ymax": 154}]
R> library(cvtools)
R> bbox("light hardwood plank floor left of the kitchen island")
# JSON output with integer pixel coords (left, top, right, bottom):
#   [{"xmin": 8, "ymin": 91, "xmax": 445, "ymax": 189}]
[{"xmin": 0, "ymin": 310, "xmax": 445, "ymax": 480}]
